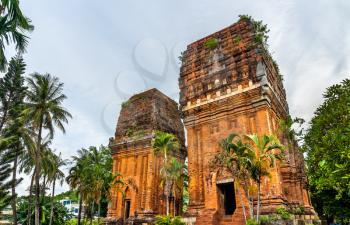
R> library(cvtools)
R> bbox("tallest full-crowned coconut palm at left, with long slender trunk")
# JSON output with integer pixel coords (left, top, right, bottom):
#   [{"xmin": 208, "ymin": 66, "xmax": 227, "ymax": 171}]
[{"xmin": 25, "ymin": 73, "xmax": 72, "ymax": 225}]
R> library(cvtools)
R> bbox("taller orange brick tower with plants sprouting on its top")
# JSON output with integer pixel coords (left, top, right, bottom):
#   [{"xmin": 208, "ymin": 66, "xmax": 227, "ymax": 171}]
[{"xmin": 179, "ymin": 16, "xmax": 314, "ymax": 225}]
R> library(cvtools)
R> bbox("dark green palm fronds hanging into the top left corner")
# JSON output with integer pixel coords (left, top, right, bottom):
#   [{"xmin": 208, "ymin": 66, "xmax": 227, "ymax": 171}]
[{"xmin": 0, "ymin": 0, "xmax": 34, "ymax": 71}]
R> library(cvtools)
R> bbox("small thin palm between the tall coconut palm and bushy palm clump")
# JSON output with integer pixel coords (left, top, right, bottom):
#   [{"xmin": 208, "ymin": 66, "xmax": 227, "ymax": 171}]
[{"xmin": 49, "ymin": 153, "xmax": 67, "ymax": 225}]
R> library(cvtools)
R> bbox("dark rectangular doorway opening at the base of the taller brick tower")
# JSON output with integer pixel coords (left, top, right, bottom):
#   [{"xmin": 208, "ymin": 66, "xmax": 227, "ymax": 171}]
[{"xmin": 217, "ymin": 182, "xmax": 236, "ymax": 215}]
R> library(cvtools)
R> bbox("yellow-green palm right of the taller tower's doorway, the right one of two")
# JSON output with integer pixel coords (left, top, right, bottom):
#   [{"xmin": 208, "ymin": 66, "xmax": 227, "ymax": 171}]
[{"xmin": 246, "ymin": 134, "xmax": 284, "ymax": 222}]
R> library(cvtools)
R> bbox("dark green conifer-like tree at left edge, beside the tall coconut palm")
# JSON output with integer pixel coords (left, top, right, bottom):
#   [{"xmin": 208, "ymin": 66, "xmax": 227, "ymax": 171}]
[{"xmin": 0, "ymin": 55, "xmax": 30, "ymax": 224}]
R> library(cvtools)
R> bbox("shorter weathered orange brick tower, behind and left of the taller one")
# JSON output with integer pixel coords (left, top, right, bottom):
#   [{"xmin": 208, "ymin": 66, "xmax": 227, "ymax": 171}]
[{"xmin": 107, "ymin": 89, "xmax": 186, "ymax": 224}]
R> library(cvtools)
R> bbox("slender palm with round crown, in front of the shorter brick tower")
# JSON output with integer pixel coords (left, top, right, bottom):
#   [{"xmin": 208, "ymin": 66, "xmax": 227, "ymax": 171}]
[{"xmin": 152, "ymin": 131, "xmax": 179, "ymax": 215}]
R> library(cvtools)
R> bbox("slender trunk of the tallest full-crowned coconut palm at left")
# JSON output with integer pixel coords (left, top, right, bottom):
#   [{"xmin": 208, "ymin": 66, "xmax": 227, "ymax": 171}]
[{"xmin": 35, "ymin": 121, "xmax": 43, "ymax": 225}]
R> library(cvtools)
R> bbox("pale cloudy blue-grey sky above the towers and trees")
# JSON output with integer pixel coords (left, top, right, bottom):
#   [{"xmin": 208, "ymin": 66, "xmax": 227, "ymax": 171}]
[{"xmin": 3, "ymin": 0, "xmax": 350, "ymax": 195}]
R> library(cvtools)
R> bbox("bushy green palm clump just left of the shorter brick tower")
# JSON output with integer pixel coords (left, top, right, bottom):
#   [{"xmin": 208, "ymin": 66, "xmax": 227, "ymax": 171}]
[{"xmin": 66, "ymin": 146, "xmax": 124, "ymax": 222}]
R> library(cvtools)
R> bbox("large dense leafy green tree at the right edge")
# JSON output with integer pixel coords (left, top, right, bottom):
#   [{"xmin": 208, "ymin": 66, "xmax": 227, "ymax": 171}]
[{"xmin": 303, "ymin": 79, "xmax": 350, "ymax": 223}]
